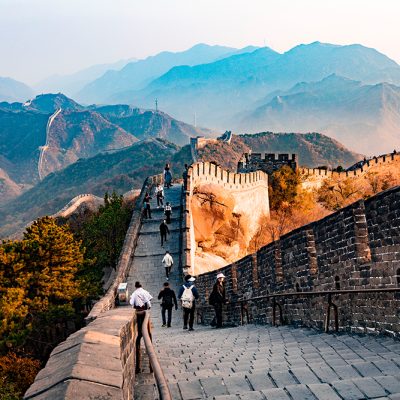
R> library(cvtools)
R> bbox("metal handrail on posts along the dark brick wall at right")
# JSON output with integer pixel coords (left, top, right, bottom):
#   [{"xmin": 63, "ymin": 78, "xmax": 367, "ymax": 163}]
[{"xmin": 198, "ymin": 288, "xmax": 400, "ymax": 333}]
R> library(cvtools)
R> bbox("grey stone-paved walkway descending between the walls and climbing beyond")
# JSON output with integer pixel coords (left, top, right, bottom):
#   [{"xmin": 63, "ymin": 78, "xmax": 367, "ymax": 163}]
[{"xmin": 129, "ymin": 186, "xmax": 400, "ymax": 400}]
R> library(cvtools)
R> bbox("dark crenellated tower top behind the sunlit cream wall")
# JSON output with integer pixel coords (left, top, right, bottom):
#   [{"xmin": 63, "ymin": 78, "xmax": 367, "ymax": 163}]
[{"xmin": 237, "ymin": 152, "xmax": 297, "ymax": 174}]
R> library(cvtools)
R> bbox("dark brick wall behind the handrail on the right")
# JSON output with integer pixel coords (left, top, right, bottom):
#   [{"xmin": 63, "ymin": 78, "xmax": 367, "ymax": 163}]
[{"xmin": 197, "ymin": 187, "xmax": 400, "ymax": 337}]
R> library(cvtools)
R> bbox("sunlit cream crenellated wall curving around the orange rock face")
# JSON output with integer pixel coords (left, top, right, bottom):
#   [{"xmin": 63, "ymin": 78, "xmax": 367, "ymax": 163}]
[{"xmin": 182, "ymin": 162, "xmax": 269, "ymax": 271}]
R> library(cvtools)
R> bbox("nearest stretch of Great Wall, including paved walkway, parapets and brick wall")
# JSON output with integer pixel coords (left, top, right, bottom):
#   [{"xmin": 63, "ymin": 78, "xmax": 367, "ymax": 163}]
[{"xmin": 25, "ymin": 160, "xmax": 400, "ymax": 400}]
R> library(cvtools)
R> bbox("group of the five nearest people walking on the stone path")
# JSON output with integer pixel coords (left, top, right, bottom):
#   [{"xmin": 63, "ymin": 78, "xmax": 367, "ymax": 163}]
[{"xmin": 130, "ymin": 272, "xmax": 227, "ymax": 331}]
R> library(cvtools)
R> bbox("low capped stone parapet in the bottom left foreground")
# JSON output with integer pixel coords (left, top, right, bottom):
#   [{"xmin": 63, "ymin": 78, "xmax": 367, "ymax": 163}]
[{"xmin": 24, "ymin": 307, "xmax": 137, "ymax": 400}]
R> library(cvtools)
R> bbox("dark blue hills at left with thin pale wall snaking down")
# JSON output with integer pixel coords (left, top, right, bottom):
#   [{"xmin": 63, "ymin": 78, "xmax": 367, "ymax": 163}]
[{"xmin": 0, "ymin": 94, "xmax": 211, "ymax": 203}]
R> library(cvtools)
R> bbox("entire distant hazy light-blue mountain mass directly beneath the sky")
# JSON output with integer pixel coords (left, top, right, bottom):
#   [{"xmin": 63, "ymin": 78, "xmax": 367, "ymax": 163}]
[{"xmin": 69, "ymin": 42, "xmax": 400, "ymax": 154}]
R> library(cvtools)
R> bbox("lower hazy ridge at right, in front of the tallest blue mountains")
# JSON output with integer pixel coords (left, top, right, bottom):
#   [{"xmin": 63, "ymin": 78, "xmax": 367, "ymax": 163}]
[{"xmin": 236, "ymin": 74, "xmax": 400, "ymax": 155}]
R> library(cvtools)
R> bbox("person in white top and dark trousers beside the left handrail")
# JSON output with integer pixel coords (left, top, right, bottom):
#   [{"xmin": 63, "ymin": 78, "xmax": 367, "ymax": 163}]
[{"xmin": 129, "ymin": 281, "xmax": 153, "ymax": 373}]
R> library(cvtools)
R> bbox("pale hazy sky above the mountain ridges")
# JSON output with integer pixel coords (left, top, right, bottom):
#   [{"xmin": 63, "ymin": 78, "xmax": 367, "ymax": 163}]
[{"xmin": 0, "ymin": 0, "xmax": 400, "ymax": 84}]
